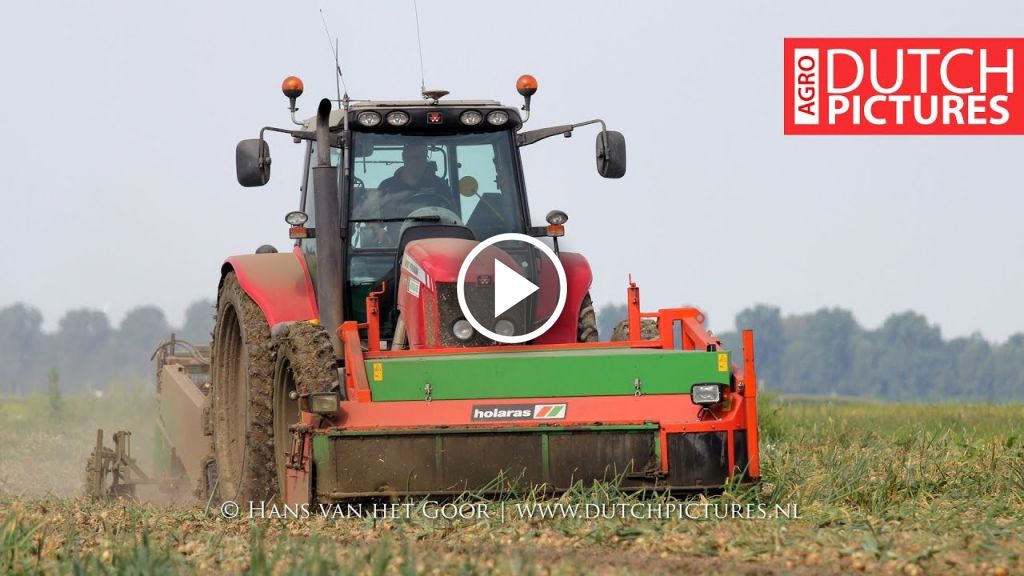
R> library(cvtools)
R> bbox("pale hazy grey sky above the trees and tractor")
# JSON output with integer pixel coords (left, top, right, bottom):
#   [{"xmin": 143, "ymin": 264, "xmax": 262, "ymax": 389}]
[{"xmin": 0, "ymin": 0, "xmax": 1024, "ymax": 340}]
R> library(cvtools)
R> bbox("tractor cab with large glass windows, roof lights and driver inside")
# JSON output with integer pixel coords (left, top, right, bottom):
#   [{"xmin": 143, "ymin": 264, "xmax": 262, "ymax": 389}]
[{"xmin": 298, "ymin": 99, "xmax": 529, "ymax": 339}]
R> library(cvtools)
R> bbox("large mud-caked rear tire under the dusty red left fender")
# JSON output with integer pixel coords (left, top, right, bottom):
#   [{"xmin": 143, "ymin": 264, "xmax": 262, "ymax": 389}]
[{"xmin": 210, "ymin": 272, "xmax": 276, "ymax": 501}]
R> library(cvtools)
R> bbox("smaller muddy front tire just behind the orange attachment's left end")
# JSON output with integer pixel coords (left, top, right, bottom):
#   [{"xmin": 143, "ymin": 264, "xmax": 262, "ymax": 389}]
[{"xmin": 272, "ymin": 322, "xmax": 338, "ymax": 494}]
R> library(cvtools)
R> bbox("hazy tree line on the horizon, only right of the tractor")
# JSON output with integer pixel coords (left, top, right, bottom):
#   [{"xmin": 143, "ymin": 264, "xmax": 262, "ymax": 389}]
[{"xmin": 598, "ymin": 304, "xmax": 1024, "ymax": 402}]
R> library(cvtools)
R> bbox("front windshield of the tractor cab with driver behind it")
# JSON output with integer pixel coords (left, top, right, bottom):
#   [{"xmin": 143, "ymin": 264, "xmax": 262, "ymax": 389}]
[{"xmin": 348, "ymin": 132, "xmax": 524, "ymax": 250}]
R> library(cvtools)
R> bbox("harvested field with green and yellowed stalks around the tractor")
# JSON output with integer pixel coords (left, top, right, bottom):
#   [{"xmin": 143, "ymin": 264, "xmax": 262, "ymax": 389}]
[{"xmin": 0, "ymin": 386, "xmax": 1024, "ymax": 575}]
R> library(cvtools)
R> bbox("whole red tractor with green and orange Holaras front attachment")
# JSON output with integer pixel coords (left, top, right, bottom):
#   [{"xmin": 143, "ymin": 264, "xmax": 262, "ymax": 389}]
[{"xmin": 90, "ymin": 76, "xmax": 760, "ymax": 503}]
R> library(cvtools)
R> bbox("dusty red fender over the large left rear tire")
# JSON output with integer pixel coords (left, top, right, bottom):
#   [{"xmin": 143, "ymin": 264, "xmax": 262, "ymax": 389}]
[{"xmin": 220, "ymin": 248, "xmax": 318, "ymax": 330}]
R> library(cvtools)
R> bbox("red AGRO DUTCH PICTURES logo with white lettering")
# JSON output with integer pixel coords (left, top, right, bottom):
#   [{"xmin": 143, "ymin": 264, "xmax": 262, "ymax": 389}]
[{"xmin": 784, "ymin": 38, "xmax": 1024, "ymax": 134}]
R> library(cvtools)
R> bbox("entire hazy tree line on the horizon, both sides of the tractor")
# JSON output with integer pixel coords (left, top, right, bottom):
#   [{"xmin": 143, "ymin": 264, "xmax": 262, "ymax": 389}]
[{"xmin": 0, "ymin": 300, "xmax": 1024, "ymax": 402}]
